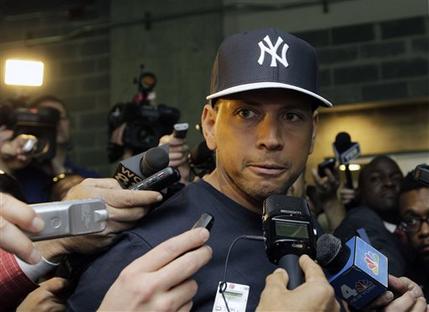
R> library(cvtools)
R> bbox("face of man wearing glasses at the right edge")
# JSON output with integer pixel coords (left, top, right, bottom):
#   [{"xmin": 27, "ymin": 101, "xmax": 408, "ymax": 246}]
[{"xmin": 399, "ymin": 187, "xmax": 429, "ymax": 266}]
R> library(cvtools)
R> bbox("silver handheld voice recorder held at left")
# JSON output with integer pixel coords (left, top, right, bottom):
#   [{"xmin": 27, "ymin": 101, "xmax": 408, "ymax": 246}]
[{"xmin": 27, "ymin": 199, "xmax": 108, "ymax": 241}]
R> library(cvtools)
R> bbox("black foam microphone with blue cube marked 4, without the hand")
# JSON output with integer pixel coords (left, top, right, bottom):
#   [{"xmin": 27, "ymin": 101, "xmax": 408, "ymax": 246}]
[{"xmin": 317, "ymin": 234, "xmax": 388, "ymax": 310}]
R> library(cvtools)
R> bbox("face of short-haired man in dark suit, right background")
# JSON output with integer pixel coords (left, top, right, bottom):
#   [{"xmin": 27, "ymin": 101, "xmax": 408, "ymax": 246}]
[{"xmin": 359, "ymin": 158, "xmax": 402, "ymax": 214}]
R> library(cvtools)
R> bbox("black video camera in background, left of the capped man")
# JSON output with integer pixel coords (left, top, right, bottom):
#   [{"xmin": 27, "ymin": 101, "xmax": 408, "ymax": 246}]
[{"xmin": 108, "ymin": 65, "xmax": 180, "ymax": 154}]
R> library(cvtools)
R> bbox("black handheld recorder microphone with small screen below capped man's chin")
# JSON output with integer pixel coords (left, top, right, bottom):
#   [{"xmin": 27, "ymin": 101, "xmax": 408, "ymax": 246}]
[{"xmin": 262, "ymin": 194, "xmax": 317, "ymax": 289}]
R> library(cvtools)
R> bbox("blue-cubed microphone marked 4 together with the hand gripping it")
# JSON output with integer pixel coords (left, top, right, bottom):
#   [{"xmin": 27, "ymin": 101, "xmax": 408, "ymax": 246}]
[{"xmin": 317, "ymin": 234, "xmax": 426, "ymax": 312}]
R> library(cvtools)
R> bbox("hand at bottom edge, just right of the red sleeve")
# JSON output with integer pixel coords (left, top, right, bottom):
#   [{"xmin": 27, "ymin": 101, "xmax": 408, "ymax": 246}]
[{"xmin": 16, "ymin": 277, "xmax": 68, "ymax": 312}]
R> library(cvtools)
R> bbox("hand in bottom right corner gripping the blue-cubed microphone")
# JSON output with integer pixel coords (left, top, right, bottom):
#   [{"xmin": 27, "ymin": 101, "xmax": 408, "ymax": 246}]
[{"xmin": 366, "ymin": 275, "xmax": 428, "ymax": 312}]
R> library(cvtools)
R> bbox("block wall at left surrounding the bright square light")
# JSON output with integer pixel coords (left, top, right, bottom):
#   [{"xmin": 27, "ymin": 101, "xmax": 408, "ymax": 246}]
[{"xmin": 0, "ymin": 1, "xmax": 110, "ymax": 174}]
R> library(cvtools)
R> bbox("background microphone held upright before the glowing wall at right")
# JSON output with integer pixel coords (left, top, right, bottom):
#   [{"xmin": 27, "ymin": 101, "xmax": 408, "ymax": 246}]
[{"xmin": 332, "ymin": 132, "xmax": 360, "ymax": 189}]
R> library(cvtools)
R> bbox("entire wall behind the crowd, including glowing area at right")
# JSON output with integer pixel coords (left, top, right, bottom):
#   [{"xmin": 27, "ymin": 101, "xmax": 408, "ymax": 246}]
[{"xmin": 0, "ymin": 0, "xmax": 429, "ymax": 175}]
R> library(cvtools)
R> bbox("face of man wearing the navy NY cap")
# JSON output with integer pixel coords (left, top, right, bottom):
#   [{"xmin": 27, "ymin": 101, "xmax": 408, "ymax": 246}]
[{"xmin": 203, "ymin": 89, "xmax": 317, "ymax": 210}]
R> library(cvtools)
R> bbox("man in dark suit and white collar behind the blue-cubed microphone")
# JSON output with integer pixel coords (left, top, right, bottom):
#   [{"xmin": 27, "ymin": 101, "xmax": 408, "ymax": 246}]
[{"xmin": 334, "ymin": 155, "xmax": 407, "ymax": 276}]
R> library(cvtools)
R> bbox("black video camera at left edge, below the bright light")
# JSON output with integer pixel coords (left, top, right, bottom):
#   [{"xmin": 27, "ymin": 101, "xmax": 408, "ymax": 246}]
[{"xmin": 0, "ymin": 105, "xmax": 60, "ymax": 161}]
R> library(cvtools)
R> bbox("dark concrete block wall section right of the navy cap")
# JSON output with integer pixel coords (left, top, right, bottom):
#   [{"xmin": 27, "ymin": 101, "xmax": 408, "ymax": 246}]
[{"xmin": 296, "ymin": 16, "xmax": 429, "ymax": 105}]
